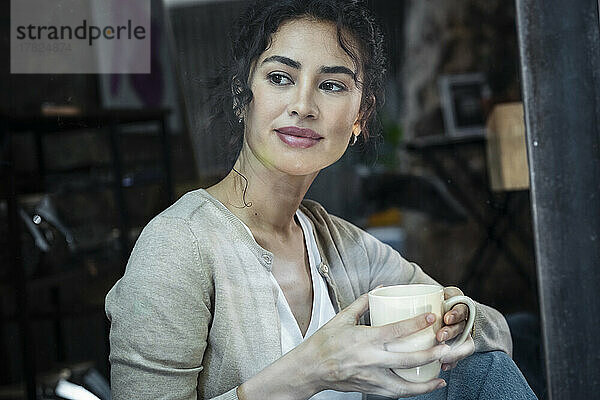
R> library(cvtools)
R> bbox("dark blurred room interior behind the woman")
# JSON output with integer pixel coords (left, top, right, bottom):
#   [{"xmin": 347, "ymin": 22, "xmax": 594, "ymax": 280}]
[{"xmin": 0, "ymin": 0, "xmax": 564, "ymax": 399}]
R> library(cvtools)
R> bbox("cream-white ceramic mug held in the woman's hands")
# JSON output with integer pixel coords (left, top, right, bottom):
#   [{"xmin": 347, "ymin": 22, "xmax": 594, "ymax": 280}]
[{"xmin": 369, "ymin": 284, "xmax": 475, "ymax": 382}]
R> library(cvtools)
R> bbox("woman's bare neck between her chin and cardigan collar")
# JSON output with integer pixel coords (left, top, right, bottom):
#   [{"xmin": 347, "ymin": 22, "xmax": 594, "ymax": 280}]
[{"xmin": 206, "ymin": 149, "xmax": 318, "ymax": 237}]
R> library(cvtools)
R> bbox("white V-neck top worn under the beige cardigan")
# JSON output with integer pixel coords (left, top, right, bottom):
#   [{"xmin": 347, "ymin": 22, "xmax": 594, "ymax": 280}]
[{"xmin": 239, "ymin": 210, "xmax": 362, "ymax": 400}]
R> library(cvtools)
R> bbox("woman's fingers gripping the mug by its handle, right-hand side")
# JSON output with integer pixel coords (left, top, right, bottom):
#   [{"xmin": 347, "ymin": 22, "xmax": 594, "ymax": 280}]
[{"xmin": 437, "ymin": 286, "xmax": 475, "ymax": 371}]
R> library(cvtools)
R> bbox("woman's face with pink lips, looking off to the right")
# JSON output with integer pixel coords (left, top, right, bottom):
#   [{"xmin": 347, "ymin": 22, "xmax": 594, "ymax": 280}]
[{"xmin": 244, "ymin": 19, "xmax": 361, "ymax": 175}]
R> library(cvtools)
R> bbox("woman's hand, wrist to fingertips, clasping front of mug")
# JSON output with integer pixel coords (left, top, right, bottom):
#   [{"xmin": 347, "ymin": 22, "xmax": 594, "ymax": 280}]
[{"xmin": 305, "ymin": 295, "xmax": 448, "ymax": 398}]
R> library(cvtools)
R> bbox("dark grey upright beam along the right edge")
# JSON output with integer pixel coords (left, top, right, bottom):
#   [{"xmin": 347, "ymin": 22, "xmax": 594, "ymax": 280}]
[{"xmin": 516, "ymin": 0, "xmax": 600, "ymax": 399}]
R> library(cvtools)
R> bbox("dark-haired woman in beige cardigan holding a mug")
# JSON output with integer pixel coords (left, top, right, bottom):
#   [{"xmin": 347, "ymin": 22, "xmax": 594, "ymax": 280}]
[{"xmin": 106, "ymin": 0, "xmax": 528, "ymax": 399}]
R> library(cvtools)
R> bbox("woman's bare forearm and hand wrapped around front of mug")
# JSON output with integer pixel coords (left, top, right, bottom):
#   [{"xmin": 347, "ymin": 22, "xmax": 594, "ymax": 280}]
[{"xmin": 238, "ymin": 294, "xmax": 449, "ymax": 400}]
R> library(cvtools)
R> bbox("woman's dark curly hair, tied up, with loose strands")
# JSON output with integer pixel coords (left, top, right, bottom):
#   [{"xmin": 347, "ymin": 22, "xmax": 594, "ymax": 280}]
[{"xmin": 210, "ymin": 0, "xmax": 387, "ymax": 164}]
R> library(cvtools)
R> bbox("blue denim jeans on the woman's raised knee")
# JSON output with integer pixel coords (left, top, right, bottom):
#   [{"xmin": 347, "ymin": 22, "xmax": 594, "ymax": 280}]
[{"xmin": 367, "ymin": 351, "xmax": 537, "ymax": 400}]
